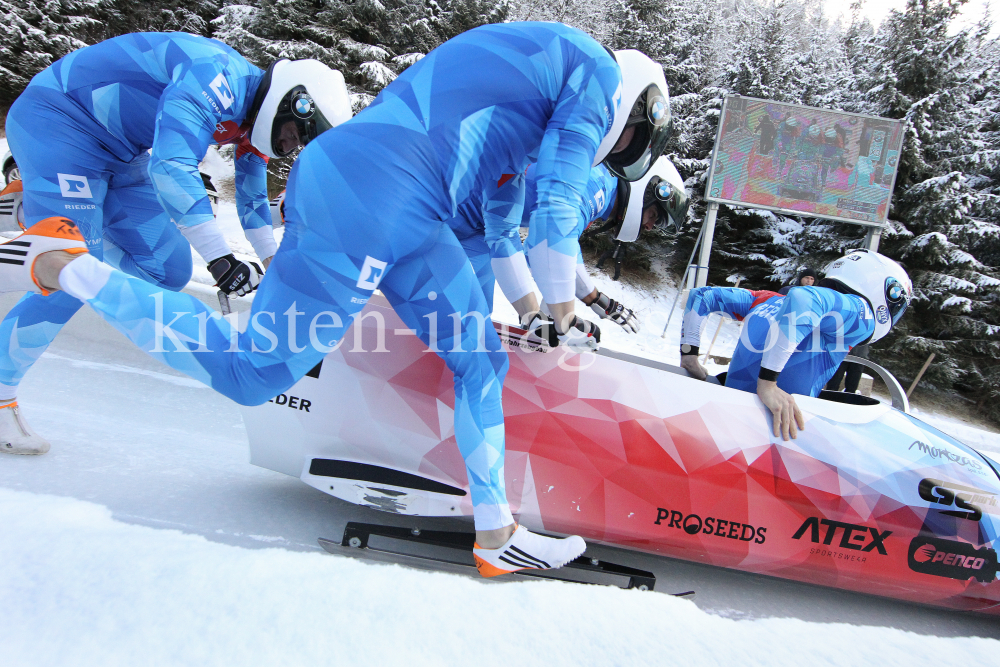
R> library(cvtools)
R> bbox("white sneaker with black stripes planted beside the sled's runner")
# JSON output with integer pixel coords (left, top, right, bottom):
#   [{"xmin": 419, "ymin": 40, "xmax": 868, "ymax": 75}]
[{"xmin": 472, "ymin": 526, "xmax": 587, "ymax": 577}]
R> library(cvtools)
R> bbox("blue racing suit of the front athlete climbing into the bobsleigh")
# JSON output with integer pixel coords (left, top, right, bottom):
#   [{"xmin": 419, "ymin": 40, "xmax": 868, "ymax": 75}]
[{"xmin": 681, "ymin": 287, "xmax": 875, "ymax": 396}]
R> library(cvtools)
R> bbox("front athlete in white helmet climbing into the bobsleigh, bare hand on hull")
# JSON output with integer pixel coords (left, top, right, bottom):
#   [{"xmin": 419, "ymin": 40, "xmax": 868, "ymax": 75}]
[{"xmin": 681, "ymin": 250, "xmax": 913, "ymax": 440}]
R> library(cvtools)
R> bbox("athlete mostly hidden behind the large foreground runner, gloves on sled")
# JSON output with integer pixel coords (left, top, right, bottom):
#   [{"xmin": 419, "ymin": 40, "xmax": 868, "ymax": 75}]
[{"xmin": 448, "ymin": 157, "xmax": 688, "ymax": 347}]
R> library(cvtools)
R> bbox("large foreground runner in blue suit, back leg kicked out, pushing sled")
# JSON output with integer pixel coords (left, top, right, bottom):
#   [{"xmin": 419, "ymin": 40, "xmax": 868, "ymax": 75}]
[{"xmin": 0, "ymin": 23, "xmax": 672, "ymax": 576}]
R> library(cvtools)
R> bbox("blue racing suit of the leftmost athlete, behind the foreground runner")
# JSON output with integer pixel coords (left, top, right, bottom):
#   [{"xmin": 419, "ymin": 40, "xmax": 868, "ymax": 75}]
[{"xmin": 0, "ymin": 33, "xmax": 277, "ymax": 397}]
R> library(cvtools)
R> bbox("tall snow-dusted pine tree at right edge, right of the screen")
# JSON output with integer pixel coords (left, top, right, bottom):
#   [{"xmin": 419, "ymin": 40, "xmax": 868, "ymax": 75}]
[{"xmin": 868, "ymin": 0, "xmax": 1000, "ymax": 418}]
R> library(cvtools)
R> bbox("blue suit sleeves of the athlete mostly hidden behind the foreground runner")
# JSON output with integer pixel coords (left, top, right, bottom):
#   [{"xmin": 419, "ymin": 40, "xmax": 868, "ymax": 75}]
[{"xmin": 448, "ymin": 165, "xmax": 618, "ymax": 311}]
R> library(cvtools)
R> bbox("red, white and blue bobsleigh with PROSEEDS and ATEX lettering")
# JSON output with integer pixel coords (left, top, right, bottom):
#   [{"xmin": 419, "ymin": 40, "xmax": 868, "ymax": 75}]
[{"xmin": 243, "ymin": 293, "xmax": 1000, "ymax": 614}]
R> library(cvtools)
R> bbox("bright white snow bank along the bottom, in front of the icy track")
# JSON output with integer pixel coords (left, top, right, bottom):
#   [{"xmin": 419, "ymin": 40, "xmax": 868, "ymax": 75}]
[{"xmin": 0, "ymin": 489, "xmax": 1000, "ymax": 667}]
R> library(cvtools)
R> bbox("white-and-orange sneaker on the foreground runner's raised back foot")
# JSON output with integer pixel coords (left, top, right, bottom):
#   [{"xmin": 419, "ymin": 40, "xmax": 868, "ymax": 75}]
[{"xmin": 0, "ymin": 216, "xmax": 87, "ymax": 296}]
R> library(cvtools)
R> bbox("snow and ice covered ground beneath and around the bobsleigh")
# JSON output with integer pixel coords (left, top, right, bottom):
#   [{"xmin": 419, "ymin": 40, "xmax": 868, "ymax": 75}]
[{"xmin": 0, "ymin": 146, "xmax": 1000, "ymax": 667}]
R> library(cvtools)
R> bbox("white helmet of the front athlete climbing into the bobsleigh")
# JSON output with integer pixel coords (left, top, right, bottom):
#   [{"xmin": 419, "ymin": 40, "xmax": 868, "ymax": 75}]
[{"xmin": 824, "ymin": 250, "xmax": 913, "ymax": 343}]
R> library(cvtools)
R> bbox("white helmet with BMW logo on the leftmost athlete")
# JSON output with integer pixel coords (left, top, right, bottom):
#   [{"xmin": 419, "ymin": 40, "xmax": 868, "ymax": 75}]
[{"xmin": 247, "ymin": 59, "xmax": 351, "ymax": 158}]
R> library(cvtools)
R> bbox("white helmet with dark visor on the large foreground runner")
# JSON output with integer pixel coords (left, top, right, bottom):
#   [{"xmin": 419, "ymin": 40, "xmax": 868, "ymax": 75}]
[{"xmin": 594, "ymin": 50, "xmax": 673, "ymax": 181}]
